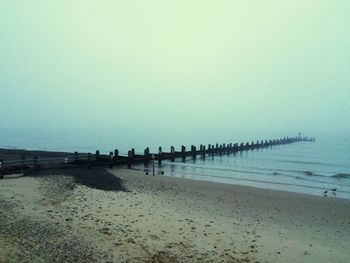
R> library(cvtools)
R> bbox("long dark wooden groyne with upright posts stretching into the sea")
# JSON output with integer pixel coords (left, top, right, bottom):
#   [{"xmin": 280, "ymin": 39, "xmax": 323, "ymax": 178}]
[{"xmin": 0, "ymin": 136, "xmax": 315, "ymax": 178}]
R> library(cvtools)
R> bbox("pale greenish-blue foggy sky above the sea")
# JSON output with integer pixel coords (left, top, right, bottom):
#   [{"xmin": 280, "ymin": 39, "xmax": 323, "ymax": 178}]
[{"xmin": 0, "ymin": 0, "xmax": 350, "ymax": 150}]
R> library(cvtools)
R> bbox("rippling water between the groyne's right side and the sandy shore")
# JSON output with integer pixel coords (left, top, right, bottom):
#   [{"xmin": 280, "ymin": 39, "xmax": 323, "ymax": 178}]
[{"xmin": 137, "ymin": 138, "xmax": 350, "ymax": 199}]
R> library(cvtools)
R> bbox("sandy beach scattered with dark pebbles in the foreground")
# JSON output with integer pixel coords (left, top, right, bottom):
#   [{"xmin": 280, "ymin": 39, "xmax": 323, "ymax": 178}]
[{"xmin": 0, "ymin": 168, "xmax": 350, "ymax": 263}]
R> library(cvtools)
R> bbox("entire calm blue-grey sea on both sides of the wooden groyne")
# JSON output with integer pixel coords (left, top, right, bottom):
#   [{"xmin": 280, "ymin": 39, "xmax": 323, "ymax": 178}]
[{"xmin": 0, "ymin": 130, "xmax": 350, "ymax": 199}]
